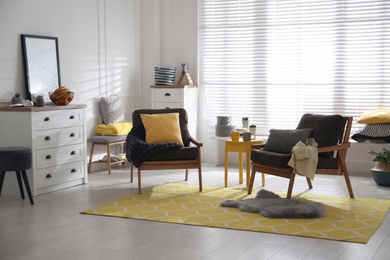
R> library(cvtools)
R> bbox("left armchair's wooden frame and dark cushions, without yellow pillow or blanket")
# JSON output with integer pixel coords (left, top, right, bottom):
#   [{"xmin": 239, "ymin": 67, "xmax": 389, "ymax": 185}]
[{"xmin": 126, "ymin": 108, "xmax": 203, "ymax": 194}]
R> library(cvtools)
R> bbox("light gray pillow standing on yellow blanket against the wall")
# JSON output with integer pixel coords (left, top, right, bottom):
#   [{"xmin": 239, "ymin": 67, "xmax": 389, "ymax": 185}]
[{"xmin": 99, "ymin": 95, "xmax": 125, "ymax": 125}]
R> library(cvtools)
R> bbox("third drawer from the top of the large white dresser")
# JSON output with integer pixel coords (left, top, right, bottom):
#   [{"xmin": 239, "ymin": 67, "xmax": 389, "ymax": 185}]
[{"xmin": 35, "ymin": 144, "xmax": 84, "ymax": 170}]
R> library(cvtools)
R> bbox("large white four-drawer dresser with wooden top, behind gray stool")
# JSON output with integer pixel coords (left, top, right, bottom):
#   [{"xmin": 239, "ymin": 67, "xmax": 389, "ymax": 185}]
[{"xmin": 0, "ymin": 105, "xmax": 88, "ymax": 196}]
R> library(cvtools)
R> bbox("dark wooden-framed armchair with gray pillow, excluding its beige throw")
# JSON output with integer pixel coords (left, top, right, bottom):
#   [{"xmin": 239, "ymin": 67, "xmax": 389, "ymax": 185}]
[{"xmin": 248, "ymin": 114, "xmax": 354, "ymax": 198}]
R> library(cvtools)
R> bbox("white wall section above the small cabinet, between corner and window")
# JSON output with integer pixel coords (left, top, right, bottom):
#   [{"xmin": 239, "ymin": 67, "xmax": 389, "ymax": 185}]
[{"xmin": 141, "ymin": 0, "xmax": 198, "ymax": 106}]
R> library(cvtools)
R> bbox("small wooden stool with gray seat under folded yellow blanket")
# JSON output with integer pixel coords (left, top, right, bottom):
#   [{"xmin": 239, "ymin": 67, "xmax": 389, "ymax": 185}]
[{"xmin": 88, "ymin": 135, "xmax": 127, "ymax": 174}]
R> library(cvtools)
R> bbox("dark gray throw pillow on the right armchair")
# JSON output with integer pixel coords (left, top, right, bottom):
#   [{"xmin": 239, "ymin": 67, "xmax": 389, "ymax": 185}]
[{"xmin": 264, "ymin": 128, "xmax": 313, "ymax": 154}]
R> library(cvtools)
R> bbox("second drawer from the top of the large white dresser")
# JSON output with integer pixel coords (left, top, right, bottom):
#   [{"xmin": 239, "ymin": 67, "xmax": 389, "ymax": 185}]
[{"xmin": 34, "ymin": 126, "xmax": 84, "ymax": 150}]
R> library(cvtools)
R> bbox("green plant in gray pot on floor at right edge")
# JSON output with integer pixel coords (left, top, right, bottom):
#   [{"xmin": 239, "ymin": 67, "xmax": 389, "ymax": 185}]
[{"xmin": 368, "ymin": 148, "xmax": 390, "ymax": 186}]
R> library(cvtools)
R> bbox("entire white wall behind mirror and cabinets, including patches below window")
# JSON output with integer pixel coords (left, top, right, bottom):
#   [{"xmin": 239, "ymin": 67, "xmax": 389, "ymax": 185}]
[{"xmin": 0, "ymin": 0, "xmax": 388, "ymax": 175}]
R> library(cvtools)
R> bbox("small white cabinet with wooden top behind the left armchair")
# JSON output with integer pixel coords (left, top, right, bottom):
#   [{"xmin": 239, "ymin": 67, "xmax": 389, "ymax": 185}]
[{"xmin": 150, "ymin": 85, "xmax": 198, "ymax": 137}]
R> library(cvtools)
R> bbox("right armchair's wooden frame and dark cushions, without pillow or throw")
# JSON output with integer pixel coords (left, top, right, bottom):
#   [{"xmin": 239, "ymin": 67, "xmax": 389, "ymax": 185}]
[{"xmin": 248, "ymin": 114, "xmax": 354, "ymax": 198}]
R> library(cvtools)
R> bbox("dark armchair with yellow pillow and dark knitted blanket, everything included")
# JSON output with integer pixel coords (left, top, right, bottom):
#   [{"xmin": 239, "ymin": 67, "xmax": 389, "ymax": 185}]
[{"xmin": 126, "ymin": 108, "xmax": 202, "ymax": 194}]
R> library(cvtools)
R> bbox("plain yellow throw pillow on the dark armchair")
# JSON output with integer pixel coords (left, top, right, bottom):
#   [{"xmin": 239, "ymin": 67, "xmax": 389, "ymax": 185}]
[{"xmin": 141, "ymin": 113, "xmax": 183, "ymax": 145}]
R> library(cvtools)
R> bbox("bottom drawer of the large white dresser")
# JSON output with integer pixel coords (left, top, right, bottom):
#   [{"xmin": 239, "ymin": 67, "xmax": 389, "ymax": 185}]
[{"xmin": 34, "ymin": 162, "xmax": 85, "ymax": 189}]
